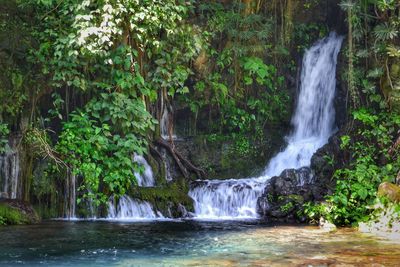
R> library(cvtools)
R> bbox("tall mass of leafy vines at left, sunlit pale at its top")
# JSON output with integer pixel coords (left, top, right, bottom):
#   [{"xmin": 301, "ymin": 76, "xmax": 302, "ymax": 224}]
[{"xmin": 22, "ymin": 0, "xmax": 197, "ymax": 204}]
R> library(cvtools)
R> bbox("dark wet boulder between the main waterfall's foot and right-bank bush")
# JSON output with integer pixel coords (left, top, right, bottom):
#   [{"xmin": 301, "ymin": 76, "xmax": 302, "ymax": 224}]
[{"xmin": 257, "ymin": 134, "xmax": 343, "ymax": 222}]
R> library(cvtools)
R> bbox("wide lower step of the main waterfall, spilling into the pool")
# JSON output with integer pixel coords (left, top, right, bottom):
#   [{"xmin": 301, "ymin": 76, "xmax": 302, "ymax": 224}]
[{"xmin": 189, "ymin": 177, "xmax": 268, "ymax": 219}]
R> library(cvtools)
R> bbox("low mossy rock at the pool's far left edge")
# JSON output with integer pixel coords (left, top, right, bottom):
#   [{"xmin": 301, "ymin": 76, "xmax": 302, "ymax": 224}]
[{"xmin": 0, "ymin": 199, "xmax": 39, "ymax": 225}]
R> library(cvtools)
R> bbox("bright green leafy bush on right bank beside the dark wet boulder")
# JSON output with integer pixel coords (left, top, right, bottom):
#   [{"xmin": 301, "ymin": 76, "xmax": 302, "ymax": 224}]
[{"xmin": 305, "ymin": 109, "xmax": 400, "ymax": 225}]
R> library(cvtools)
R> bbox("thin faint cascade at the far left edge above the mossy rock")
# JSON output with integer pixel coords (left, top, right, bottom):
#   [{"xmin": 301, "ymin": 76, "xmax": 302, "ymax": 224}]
[{"xmin": 0, "ymin": 144, "xmax": 22, "ymax": 199}]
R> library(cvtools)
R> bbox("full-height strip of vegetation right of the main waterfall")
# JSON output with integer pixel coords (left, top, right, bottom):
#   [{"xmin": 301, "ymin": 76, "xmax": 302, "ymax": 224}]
[{"xmin": 306, "ymin": 1, "xmax": 400, "ymax": 225}]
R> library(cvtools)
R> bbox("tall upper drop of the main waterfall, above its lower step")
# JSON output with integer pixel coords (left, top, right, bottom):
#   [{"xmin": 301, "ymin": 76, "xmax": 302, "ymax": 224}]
[{"xmin": 264, "ymin": 33, "xmax": 343, "ymax": 180}]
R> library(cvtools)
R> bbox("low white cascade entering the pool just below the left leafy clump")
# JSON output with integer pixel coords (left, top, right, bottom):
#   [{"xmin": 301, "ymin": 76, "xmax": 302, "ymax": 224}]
[{"xmin": 107, "ymin": 196, "xmax": 163, "ymax": 220}]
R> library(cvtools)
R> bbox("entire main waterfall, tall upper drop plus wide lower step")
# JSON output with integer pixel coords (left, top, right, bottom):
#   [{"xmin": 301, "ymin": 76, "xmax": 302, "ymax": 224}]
[{"xmin": 189, "ymin": 33, "xmax": 343, "ymax": 219}]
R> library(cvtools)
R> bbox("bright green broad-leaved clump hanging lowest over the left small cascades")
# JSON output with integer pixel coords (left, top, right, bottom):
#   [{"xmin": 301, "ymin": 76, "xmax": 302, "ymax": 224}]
[{"xmin": 56, "ymin": 112, "xmax": 146, "ymax": 204}]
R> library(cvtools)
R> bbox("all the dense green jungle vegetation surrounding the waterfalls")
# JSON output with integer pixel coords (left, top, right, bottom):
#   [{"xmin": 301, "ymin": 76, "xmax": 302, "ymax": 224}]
[{"xmin": 0, "ymin": 0, "xmax": 400, "ymax": 227}]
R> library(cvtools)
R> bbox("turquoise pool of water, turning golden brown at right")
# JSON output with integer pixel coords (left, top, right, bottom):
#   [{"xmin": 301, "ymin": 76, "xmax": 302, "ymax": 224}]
[{"xmin": 0, "ymin": 221, "xmax": 400, "ymax": 266}]
